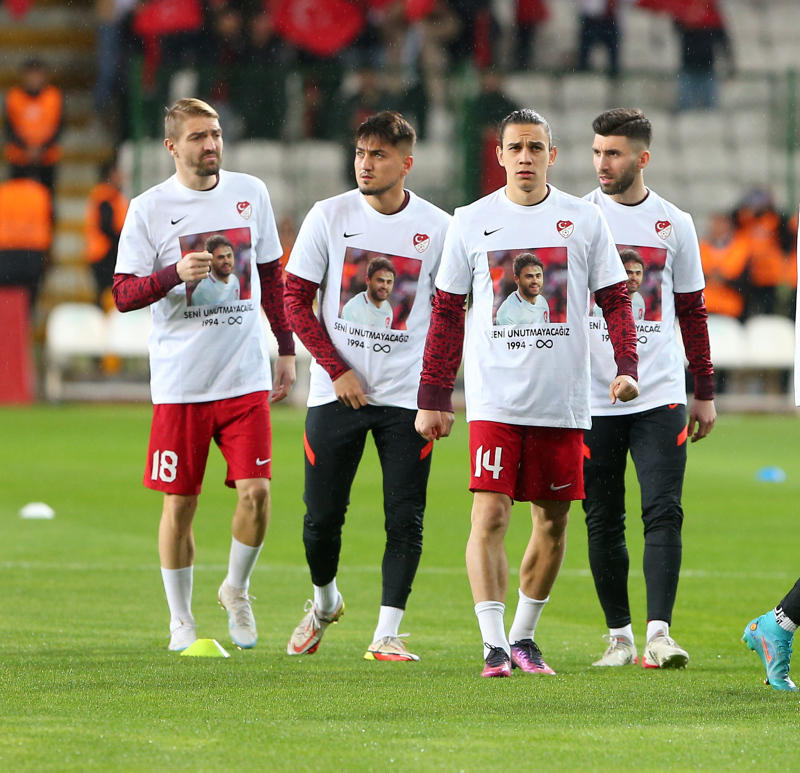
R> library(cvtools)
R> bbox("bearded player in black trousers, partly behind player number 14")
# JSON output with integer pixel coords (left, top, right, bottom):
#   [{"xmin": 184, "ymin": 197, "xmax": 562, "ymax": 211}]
[{"xmin": 584, "ymin": 108, "xmax": 716, "ymax": 668}]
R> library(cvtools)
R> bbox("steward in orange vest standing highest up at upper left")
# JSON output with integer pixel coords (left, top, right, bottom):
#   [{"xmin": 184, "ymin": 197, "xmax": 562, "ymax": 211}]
[{"xmin": 3, "ymin": 59, "xmax": 64, "ymax": 191}]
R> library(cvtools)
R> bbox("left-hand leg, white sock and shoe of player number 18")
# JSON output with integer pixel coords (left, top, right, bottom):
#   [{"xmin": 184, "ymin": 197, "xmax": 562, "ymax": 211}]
[{"xmin": 158, "ymin": 494, "xmax": 197, "ymax": 652}]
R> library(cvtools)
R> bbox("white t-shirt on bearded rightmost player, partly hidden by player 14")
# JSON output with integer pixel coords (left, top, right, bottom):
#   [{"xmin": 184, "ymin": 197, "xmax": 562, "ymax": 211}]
[{"xmin": 585, "ymin": 188, "xmax": 705, "ymax": 416}]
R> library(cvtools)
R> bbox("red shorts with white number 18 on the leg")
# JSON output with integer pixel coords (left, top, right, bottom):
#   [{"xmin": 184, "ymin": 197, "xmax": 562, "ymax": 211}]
[{"xmin": 144, "ymin": 392, "xmax": 272, "ymax": 496}]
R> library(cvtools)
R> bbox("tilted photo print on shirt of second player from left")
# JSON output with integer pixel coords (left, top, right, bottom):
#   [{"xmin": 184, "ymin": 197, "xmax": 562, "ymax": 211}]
[{"xmin": 339, "ymin": 247, "xmax": 422, "ymax": 330}]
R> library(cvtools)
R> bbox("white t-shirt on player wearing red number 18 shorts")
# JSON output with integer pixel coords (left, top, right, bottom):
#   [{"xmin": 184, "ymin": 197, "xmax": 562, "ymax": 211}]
[{"xmin": 116, "ymin": 171, "xmax": 283, "ymax": 404}]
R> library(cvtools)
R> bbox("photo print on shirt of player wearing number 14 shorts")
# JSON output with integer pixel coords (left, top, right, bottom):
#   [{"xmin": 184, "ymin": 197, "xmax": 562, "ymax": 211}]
[{"xmin": 486, "ymin": 247, "xmax": 568, "ymax": 325}]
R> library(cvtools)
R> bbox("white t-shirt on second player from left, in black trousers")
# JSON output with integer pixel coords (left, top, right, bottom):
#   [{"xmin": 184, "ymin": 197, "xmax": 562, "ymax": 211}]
[{"xmin": 286, "ymin": 190, "xmax": 450, "ymax": 409}]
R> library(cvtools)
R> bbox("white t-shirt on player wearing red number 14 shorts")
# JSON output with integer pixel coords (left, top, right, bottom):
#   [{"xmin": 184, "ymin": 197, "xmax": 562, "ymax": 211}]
[{"xmin": 436, "ymin": 185, "xmax": 627, "ymax": 429}]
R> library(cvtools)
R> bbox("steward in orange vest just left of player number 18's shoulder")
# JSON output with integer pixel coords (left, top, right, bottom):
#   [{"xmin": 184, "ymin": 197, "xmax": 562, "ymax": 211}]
[{"xmin": 84, "ymin": 161, "xmax": 128, "ymax": 307}]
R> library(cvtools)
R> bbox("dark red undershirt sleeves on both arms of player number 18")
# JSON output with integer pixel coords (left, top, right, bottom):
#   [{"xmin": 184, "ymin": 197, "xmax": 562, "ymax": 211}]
[{"xmin": 111, "ymin": 260, "xmax": 294, "ymax": 356}]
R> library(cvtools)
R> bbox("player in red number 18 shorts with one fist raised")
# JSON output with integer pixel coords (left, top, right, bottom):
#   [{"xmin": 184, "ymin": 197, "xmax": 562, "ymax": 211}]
[{"xmin": 113, "ymin": 99, "xmax": 295, "ymax": 651}]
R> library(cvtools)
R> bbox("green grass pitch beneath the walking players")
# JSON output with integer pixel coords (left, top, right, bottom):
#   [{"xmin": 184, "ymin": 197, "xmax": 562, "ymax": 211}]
[{"xmin": 0, "ymin": 406, "xmax": 800, "ymax": 771}]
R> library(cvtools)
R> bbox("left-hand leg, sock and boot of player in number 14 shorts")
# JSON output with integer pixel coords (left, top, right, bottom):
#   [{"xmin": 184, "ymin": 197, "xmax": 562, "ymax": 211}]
[{"xmin": 466, "ymin": 491, "xmax": 512, "ymax": 676}]
